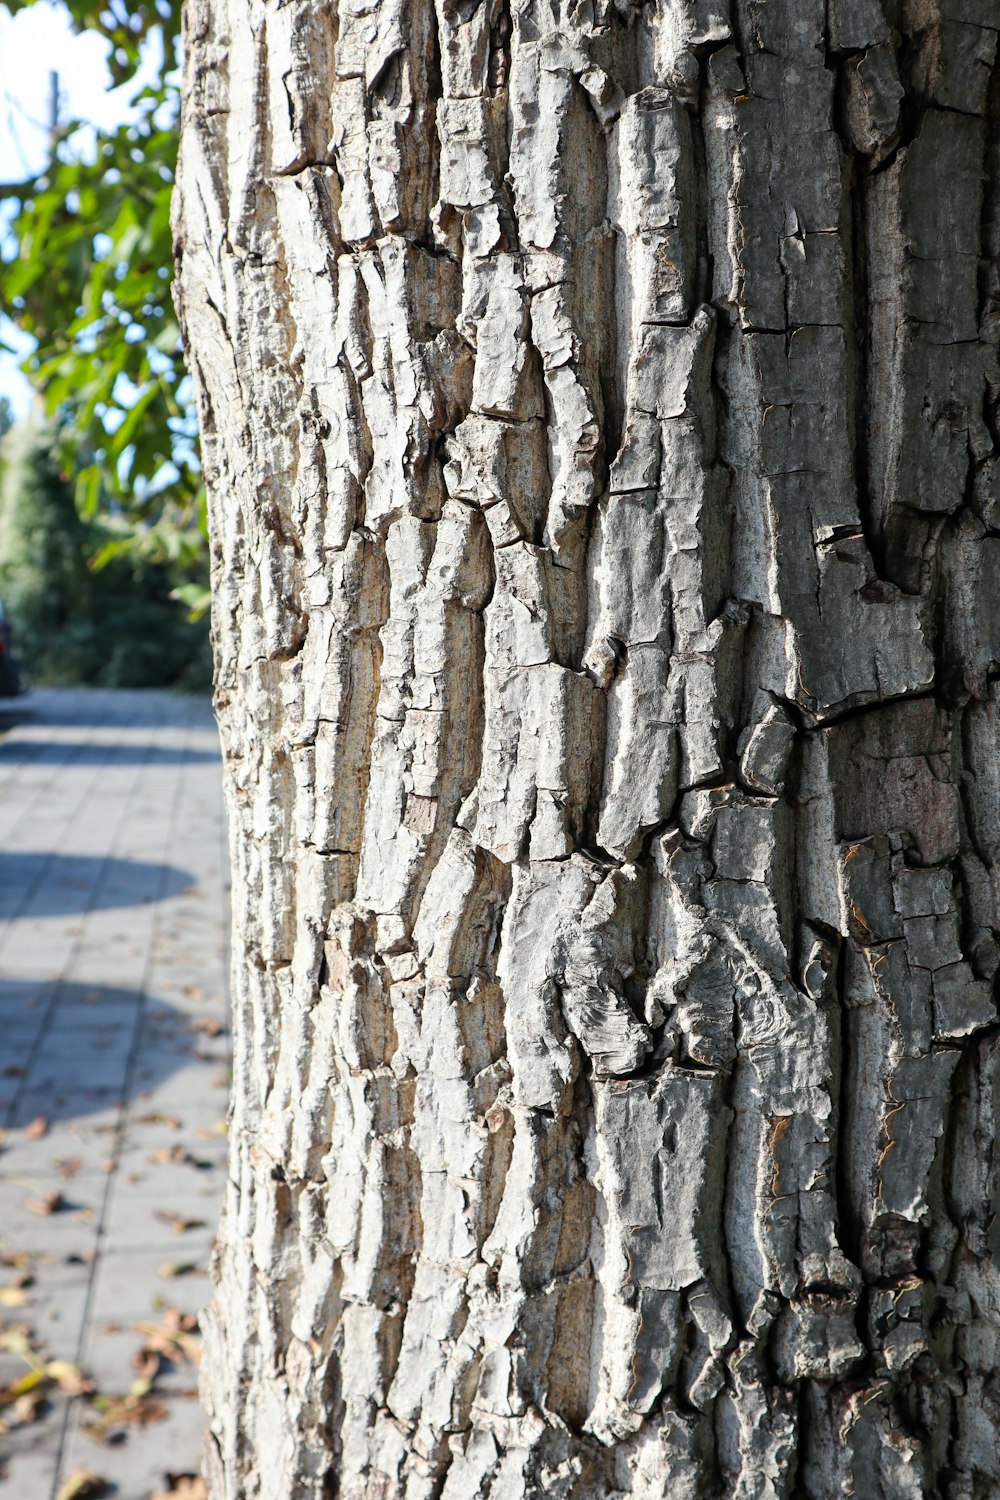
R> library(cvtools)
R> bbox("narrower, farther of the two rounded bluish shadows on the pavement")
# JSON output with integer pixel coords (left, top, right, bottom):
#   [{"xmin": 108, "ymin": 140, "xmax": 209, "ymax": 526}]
[{"xmin": 0, "ymin": 851, "xmax": 196, "ymax": 918}]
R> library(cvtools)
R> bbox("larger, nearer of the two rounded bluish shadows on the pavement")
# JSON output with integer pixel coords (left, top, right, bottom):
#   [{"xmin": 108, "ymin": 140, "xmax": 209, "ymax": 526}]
[{"xmin": 0, "ymin": 980, "xmax": 225, "ymax": 1130}]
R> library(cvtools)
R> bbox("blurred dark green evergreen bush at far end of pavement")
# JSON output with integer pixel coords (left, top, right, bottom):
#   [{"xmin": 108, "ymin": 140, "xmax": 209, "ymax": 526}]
[{"xmin": 0, "ymin": 423, "xmax": 210, "ymax": 689}]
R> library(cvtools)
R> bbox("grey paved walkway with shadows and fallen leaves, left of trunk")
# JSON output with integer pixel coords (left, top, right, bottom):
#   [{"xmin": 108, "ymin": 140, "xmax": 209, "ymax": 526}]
[{"xmin": 0, "ymin": 690, "xmax": 228, "ymax": 1500}]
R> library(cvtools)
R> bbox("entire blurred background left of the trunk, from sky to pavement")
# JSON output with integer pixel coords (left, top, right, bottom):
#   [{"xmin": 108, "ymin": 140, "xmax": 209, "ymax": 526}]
[{"xmin": 0, "ymin": 0, "xmax": 229, "ymax": 1500}]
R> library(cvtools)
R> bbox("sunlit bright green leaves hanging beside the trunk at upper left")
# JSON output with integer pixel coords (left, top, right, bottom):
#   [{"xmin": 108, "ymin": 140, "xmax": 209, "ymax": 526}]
[{"xmin": 0, "ymin": 0, "xmax": 207, "ymax": 605}]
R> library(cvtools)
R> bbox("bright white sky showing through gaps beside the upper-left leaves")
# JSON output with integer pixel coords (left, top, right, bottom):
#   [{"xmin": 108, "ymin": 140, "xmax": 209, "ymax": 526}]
[{"xmin": 0, "ymin": 0, "xmax": 161, "ymax": 416}]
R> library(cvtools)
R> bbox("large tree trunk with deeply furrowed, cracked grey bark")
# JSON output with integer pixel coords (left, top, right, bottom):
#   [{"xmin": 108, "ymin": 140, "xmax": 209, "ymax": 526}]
[{"xmin": 178, "ymin": 0, "xmax": 1000, "ymax": 1500}]
